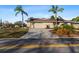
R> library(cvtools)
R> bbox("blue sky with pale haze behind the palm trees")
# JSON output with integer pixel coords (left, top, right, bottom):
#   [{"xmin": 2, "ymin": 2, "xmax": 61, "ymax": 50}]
[{"xmin": 0, "ymin": 5, "xmax": 79, "ymax": 23}]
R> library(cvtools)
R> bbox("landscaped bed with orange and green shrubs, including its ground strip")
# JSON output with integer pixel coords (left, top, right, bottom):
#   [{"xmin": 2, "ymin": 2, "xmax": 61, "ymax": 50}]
[{"xmin": 50, "ymin": 24, "xmax": 79, "ymax": 37}]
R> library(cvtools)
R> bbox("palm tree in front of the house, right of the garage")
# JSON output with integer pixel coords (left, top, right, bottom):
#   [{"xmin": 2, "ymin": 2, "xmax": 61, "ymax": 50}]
[{"xmin": 49, "ymin": 5, "xmax": 64, "ymax": 26}]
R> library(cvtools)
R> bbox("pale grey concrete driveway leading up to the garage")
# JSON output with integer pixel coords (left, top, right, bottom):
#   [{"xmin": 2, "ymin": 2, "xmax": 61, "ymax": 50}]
[{"xmin": 21, "ymin": 29, "xmax": 58, "ymax": 38}]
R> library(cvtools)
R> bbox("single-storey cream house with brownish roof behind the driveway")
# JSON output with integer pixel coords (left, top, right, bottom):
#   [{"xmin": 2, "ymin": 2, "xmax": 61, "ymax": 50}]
[{"xmin": 27, "ymin": 18, "xmax": 79, "ymax": 28}]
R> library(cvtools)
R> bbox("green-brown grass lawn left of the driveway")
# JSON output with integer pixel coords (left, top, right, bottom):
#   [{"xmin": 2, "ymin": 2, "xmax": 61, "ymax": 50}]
[{"xmin": 0, "ymin": 28, "xmax": 28, "ymax": 38}]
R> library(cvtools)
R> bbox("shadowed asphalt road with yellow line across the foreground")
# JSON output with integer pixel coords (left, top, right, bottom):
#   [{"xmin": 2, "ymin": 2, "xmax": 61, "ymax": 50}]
[{"xmin": 0, "ymin": 38, "xmax": 79, "ymax": 53}]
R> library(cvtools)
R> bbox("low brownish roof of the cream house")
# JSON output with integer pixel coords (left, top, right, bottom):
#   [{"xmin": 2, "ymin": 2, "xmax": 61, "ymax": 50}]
[{"xmin": 28, "ymin": 18, "xmax": 79, "ymax": 24}]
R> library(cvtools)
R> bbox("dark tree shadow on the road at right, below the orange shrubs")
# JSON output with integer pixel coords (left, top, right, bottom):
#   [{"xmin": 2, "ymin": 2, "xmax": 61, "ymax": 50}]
[{"xmin": 58, "ymin": 38, "xmax": 79, "ymax": 53}]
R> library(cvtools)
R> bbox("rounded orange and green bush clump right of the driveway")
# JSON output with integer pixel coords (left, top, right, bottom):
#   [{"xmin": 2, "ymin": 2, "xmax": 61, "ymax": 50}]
[{"xmin": 52, "ymin": 24, "xmax": 75, "ymax": 36}]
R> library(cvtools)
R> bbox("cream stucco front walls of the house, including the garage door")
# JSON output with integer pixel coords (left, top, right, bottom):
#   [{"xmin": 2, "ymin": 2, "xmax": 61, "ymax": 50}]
[{"xmin": 27, "ymin": 22, "xmax": 79, "ymax": 28}]
